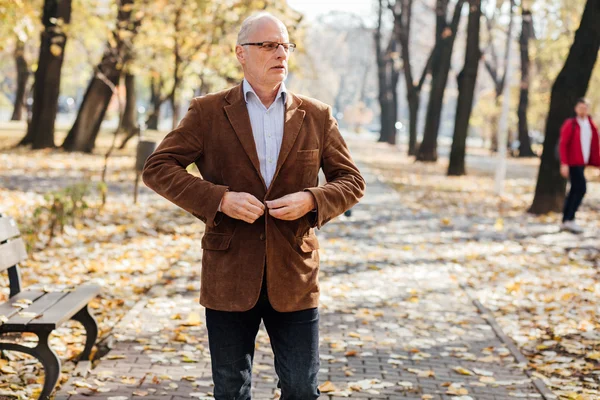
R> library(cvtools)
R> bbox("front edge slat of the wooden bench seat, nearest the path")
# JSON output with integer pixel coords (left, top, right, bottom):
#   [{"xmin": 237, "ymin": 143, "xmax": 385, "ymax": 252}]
[{"xmin": 28, "ymin": 284, "xmax": 100, "ymax": 329}]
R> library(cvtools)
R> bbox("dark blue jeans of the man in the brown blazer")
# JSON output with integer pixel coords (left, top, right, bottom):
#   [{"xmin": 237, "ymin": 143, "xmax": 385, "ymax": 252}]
[{"xmin": 206, "ymin": 276, "xmax": 321, "ymax": 400}]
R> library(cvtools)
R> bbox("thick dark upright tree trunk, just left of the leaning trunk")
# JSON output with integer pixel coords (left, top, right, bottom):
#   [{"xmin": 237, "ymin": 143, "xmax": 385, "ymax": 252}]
[{"xmin": 19, "ymin": 0, "xmax": 71, "ymax": 149}]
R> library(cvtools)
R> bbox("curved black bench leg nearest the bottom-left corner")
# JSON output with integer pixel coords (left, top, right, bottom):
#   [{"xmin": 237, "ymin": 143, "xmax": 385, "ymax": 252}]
[{"xmin": 0, "ymin": 331, "xmax": 60, "ymax": 400}]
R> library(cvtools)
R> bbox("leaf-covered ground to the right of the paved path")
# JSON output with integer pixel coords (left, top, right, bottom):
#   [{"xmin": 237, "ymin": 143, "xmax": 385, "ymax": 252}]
[{"xmin": 346, "ymin": 133, "xmax": 600, "ymax": 399}]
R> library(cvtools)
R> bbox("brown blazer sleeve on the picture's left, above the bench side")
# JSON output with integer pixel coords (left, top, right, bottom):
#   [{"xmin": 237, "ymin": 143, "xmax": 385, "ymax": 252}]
[{"xmin": 142, "ymin": 99, "xmax": 228, "ymax": 228}]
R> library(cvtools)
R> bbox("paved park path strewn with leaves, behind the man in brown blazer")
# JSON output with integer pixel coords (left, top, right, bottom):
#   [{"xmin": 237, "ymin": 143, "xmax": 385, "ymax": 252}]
[{"xmin": 57, "ymin": 167, "xmax": 541, "ymax": 400}]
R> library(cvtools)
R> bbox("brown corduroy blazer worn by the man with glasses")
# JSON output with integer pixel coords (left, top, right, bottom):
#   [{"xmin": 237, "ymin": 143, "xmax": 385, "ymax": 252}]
[{"xmin": 142, "ymin": 85, "xmax": 365, "ymax": 312}]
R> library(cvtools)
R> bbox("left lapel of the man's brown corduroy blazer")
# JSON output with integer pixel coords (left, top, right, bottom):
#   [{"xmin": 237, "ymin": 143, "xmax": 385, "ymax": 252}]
[{"xmin": 224, "ymin": 84, "xmax": 266, "ymax": 191}]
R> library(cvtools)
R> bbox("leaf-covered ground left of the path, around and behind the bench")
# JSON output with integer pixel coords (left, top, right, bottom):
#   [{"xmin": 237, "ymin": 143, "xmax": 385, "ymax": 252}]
[{"xmin": 0, "ymin": 129, "xmax": 204, "ymax": 398}]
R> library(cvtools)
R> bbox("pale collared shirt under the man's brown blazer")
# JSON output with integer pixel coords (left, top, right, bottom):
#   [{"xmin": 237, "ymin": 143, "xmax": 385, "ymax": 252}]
[{"xmin": 242, "ymin": 78, "xmax": 287, "ymax": 188}]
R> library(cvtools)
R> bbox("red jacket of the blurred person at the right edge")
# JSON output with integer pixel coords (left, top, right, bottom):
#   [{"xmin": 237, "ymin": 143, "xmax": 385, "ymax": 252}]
[{"xmin": 558, "ymin": 117, "xmax": 600, "ymax": 167}]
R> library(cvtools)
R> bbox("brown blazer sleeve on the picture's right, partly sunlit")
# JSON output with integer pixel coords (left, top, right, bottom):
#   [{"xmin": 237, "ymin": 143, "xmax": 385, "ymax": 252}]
[{"xmin": 306, "ymin": 107, "xmax": 365, "ymax": 228}]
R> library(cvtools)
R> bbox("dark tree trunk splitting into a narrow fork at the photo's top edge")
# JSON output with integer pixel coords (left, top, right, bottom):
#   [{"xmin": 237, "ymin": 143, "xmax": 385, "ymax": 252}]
[{"xmin": 417, "ymin": 0, "xmax": 464, "ymax": 162}]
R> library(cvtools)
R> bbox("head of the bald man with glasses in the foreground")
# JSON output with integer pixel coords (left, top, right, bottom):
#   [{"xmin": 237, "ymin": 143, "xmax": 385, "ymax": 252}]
[{"xmin": 236, "ymin": 18, "xmax": 290, "ymax": 86}]
